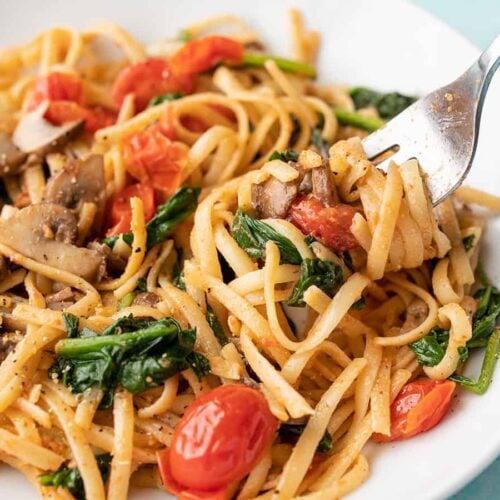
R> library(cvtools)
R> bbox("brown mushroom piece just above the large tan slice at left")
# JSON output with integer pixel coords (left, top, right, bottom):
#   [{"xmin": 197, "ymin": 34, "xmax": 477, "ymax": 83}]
[{"xmin": 43, "ymin": 155, "xmax": 106, "ymax": 233}]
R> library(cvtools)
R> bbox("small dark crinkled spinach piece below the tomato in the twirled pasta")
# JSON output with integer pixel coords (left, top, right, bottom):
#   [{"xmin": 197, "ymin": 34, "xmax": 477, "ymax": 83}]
[{"xmin": 286, "ymin": 259, "xmax": 343, "ymax": 307}]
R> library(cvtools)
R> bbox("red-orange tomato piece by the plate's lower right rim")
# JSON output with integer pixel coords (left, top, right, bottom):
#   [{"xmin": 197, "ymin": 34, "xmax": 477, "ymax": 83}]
[{"xmin": 374, "ymin": 379, "xmax": 456, "ymax": 443}]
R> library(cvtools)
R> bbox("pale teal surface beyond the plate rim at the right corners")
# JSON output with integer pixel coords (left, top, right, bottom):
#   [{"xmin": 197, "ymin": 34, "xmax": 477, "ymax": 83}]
[{"xmin": 413, "ymin": 0, "xmax": 500, "ymax": 500}]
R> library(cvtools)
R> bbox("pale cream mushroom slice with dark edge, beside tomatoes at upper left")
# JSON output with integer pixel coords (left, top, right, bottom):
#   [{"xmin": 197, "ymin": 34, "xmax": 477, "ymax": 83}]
[{"xmin": 12, "ymin": 101, "xmax": 84, "ymax": 157}]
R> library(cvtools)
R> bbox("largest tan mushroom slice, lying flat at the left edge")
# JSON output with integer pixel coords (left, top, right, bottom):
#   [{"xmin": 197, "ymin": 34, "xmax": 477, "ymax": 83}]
[{"xmin": 0, "ymin": 203, "xmax": 103, "ymax": 281}]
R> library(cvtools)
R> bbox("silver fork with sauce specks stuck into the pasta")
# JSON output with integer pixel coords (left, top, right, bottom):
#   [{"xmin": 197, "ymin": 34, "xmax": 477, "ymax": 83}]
[{"xmin": 363, "ymin": 36, "xmax": 500, "ymax": 205}]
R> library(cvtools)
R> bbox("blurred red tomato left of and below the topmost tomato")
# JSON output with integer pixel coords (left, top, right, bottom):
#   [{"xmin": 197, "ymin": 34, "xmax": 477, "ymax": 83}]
[{"xmin": 111, "ymin": 58, "xmax": 193, "ymax": 111}]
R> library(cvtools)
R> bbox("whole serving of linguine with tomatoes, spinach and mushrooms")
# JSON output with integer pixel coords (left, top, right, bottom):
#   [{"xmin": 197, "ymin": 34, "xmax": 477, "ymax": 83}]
[{"xmin": 0, "ymin": 11, "xmax": 500, "ymax": 500}]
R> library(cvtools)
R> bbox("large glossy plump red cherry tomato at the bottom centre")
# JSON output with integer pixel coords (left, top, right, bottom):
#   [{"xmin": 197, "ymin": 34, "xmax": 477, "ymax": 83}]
[{"xmin": 157, "ymin": 384, "xmax": 278, "ymax": 500}]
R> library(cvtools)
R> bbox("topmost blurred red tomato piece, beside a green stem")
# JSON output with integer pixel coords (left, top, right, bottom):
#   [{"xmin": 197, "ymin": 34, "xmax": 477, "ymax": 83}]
[{"xmin": 169, "ymin": 36, "xmax": 244, "ymax": 75}]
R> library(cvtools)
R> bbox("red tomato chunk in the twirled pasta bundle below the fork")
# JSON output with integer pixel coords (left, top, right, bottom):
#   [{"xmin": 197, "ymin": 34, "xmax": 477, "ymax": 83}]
[{"xmin": 288, "ymin": 196, "xmax": 358, "ymax": 252}]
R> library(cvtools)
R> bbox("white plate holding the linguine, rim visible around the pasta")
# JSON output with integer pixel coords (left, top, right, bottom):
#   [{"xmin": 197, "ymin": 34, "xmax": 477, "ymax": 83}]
[{"xmin": 0, "ymin": 0, "xmax": 500, "ymax": 500}]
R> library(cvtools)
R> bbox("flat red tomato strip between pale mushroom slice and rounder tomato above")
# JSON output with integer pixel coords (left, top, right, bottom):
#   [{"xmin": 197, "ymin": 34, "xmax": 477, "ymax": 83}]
[{"xmin": 44, "ymin": 101, "xmax": 116, "ymax": 134}]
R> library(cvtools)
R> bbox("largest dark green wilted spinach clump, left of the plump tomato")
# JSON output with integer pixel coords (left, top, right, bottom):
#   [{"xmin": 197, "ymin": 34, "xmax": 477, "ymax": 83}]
[{"xmin": 50, "ymin": 316, "xmax": 208, "ymax": 407}]
